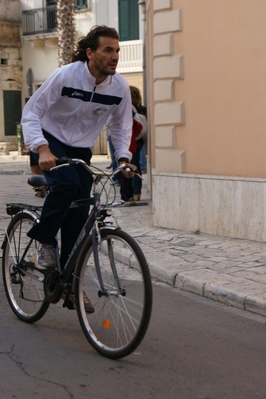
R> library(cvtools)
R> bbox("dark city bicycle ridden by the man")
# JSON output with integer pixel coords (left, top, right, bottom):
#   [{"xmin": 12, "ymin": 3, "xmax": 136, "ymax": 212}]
[{"xmin": 2, "ymin": 159, "xmax": 152, "ymax": 359}]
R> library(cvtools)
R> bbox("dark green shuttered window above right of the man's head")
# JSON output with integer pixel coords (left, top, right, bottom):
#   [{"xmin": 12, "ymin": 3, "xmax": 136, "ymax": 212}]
[{"xmin": 118, "ymin": 0, "xmax": 139, "ymax": 41}]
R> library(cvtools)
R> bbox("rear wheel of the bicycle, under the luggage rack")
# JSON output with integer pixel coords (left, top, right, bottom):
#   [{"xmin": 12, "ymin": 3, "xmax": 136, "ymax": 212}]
[{"xmin": 2, "ymin": 211, "xmax": 50, "ymax": 323}]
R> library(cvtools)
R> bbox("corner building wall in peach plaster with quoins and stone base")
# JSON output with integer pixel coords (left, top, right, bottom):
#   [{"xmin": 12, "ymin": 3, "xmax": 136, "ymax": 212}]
[{"xmin": 145, "ymin": 0, "xmax": 266, "ymax": 241}]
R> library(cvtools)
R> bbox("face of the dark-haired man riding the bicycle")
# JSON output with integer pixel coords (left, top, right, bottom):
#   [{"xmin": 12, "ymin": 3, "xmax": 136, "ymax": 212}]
[{"xmin": 86, "ymin": 36, "xmax": 120, "ymax": 83}]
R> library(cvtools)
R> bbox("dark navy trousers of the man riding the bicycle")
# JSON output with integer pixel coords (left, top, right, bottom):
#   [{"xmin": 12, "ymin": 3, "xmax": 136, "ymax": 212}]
[{"xmin": 28, "ymin": 132, "xmax": 92, "ymax": 268}]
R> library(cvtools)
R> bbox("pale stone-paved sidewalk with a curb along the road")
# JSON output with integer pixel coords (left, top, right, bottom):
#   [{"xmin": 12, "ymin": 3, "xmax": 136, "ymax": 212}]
[{"xmin": 0, "ymin": 156, "xmax": 266, "ymax": 316}]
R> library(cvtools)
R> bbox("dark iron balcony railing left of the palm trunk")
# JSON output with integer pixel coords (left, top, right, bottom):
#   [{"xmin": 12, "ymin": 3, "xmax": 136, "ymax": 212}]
[{"xmin": 22, "ymin": 5, "xmax": 56, "ymax": 36}]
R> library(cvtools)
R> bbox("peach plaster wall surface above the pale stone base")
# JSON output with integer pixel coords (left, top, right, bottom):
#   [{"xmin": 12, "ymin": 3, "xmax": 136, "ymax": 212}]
[{"xmin": 150, "ymin": 0, "xmax": 266, "ymax": 177}]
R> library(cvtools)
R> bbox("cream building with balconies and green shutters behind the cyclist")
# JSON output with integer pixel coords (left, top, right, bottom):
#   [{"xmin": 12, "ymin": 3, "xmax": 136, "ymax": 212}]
[{"xmin": 21, "ymin": 0, "xmax": 143, "ymax": 154}]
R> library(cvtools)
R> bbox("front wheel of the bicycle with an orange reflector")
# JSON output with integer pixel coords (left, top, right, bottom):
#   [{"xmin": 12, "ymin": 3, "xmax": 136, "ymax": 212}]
[{"xmin": 74, "ymin": 228, "xmax": 152, "ymax": 359}]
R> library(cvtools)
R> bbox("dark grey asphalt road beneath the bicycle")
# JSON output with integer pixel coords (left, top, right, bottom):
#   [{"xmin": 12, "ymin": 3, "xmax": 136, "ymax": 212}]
[{"xmin": 0, "ymin": 283, "xmax": 266, "ymax": 399}]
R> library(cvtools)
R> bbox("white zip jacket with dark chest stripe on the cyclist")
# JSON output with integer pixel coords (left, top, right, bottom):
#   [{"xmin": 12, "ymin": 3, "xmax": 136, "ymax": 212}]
[{"xmin": 21, "ymin": 61, "xmax": 132, "ymax": 159}]
